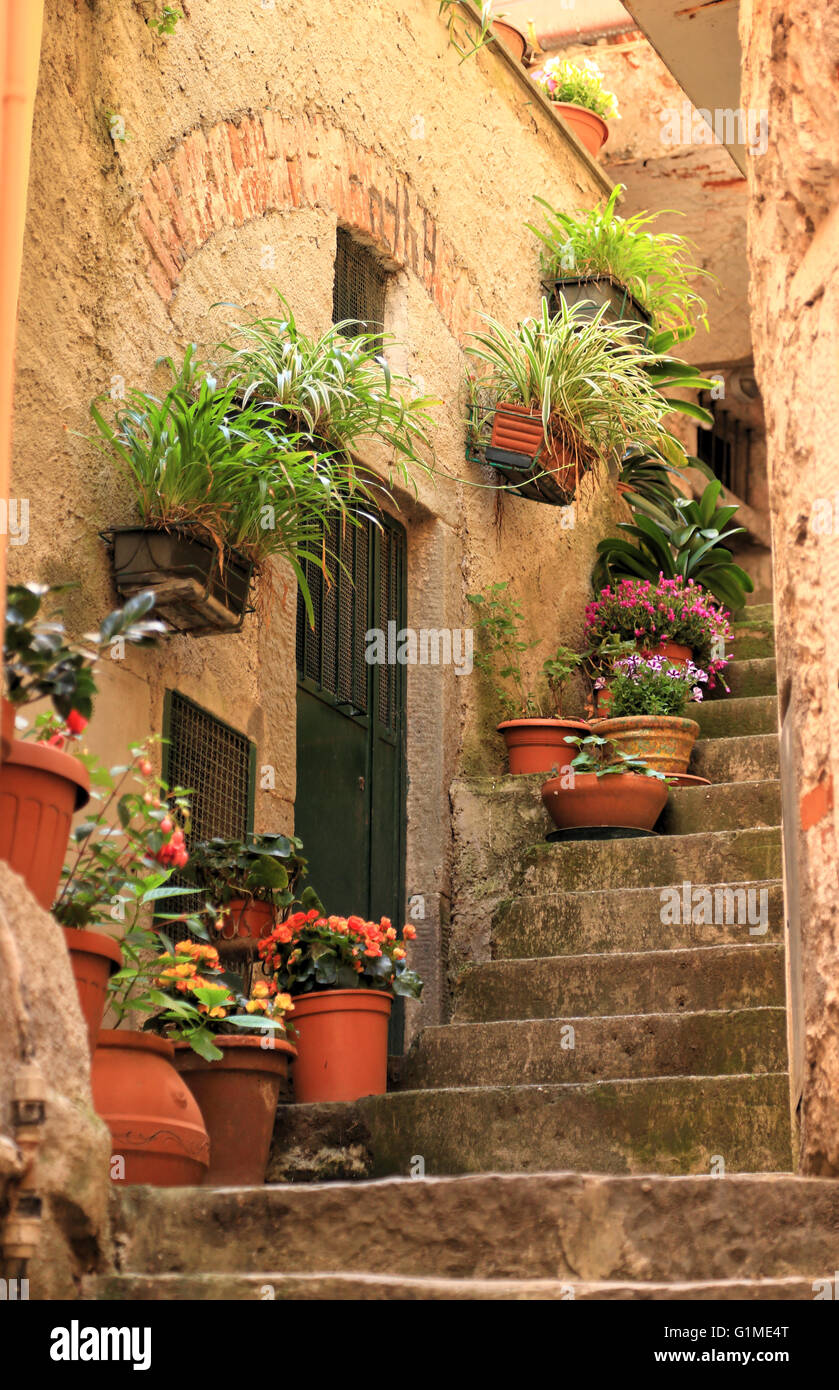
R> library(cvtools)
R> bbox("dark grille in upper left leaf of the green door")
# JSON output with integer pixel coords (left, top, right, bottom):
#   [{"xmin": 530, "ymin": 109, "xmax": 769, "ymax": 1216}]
[{"xmin": 297, "ymin": 520, "xmax": 369, "ymax": 714}]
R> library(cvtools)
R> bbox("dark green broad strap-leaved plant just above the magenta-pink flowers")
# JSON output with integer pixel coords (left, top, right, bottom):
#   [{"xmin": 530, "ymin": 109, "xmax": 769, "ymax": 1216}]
[{"xmin": 592, "ymin": 481, "xmax": 754, "ymax": 609}]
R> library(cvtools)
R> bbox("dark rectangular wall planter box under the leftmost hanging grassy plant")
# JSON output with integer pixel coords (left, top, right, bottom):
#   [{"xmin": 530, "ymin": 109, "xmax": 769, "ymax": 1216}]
[{"xmin": 103, "ymin": 527, "xmax": 253, "ymax": 635}]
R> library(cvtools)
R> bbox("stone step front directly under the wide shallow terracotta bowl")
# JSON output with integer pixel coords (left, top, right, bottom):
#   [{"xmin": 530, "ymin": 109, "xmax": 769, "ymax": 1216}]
[{"xmin": 511, "ymin": 827, "xmax": 781, "ymax": 894}]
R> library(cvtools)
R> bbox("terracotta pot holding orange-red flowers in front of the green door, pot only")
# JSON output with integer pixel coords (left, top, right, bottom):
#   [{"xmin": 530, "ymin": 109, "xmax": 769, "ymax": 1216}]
[{"xmin": 292, "ymin": 990, "xmax": 393, "ymax": 1102}]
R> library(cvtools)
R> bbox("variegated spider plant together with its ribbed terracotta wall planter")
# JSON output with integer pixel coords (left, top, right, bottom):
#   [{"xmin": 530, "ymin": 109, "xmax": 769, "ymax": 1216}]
[{"xmin": 467, "ymin": 299, "xmax": 685, "ymax": 503}]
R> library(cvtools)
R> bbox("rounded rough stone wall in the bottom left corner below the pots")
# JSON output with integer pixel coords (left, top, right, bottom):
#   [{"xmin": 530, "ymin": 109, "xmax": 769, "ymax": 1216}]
[{"xmin": 0, "ymin": 863, "xmax": 111, "ymax": 1298}]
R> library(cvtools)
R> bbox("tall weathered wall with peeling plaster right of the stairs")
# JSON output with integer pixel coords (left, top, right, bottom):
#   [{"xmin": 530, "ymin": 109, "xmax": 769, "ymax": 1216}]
[{"xmin": 740, "ymin": 0, "xmax": 839, "ymax": 1175}]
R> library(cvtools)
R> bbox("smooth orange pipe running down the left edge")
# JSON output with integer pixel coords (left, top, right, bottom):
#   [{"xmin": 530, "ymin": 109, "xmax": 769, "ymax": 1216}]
[{"xmin": 0, "ymin": 0, "xmax": 43, "ymax": 613}]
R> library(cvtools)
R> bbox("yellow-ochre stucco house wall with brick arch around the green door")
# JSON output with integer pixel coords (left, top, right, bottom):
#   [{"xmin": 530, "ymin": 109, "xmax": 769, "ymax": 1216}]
[{"xmin": 10, "ymin": 0, "xmax": 614, "ymax": 1034}]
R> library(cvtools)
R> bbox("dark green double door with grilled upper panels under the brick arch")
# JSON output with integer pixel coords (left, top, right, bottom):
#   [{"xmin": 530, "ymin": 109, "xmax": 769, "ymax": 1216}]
[{"xmin": 294, "ymin": 517, "xmax": 406, "ymax": 1051}]
